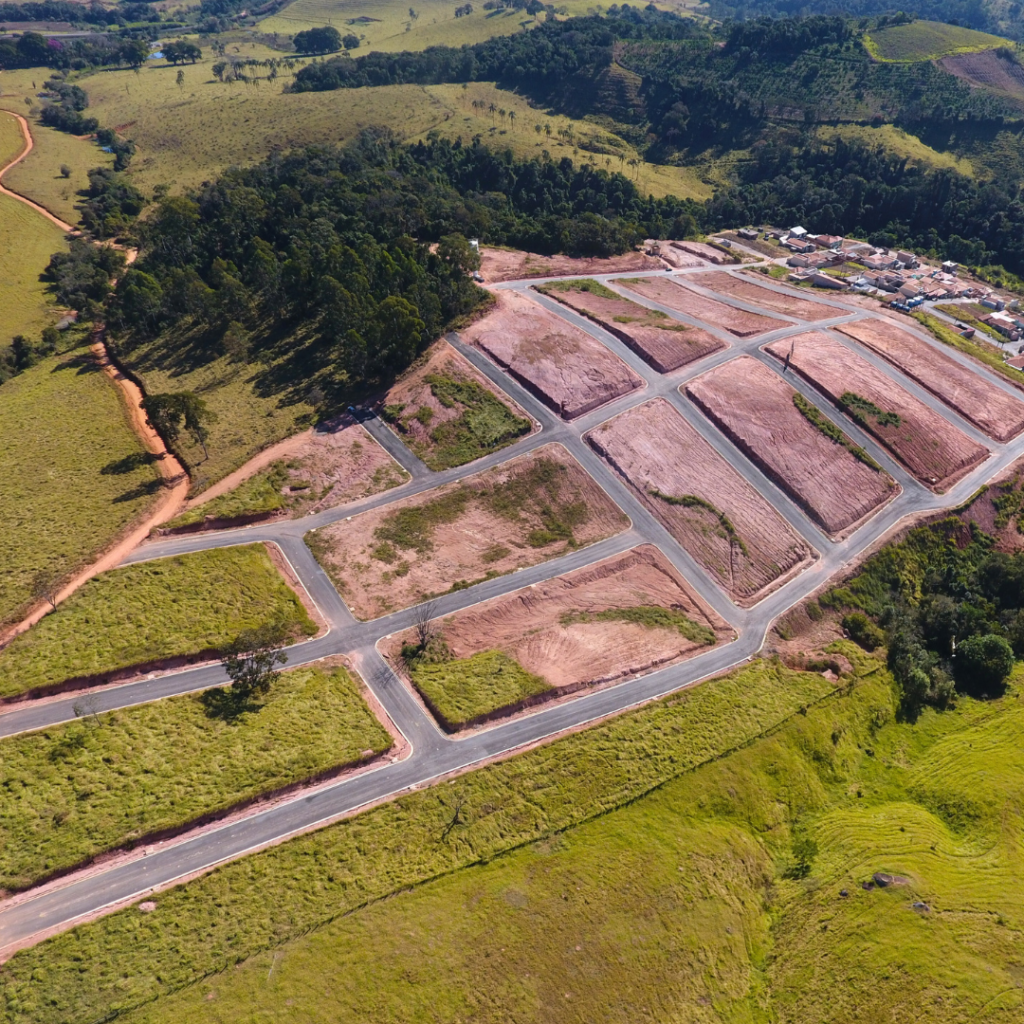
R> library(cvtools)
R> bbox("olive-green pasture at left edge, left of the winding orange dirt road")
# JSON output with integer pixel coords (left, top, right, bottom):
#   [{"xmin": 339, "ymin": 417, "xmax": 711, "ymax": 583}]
[{"xmin": 0, "ymin": 348, "xmax": 160, "ymax": 623}]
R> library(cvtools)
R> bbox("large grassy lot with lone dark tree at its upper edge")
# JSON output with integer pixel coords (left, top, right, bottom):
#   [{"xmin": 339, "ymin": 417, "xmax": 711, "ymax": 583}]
[{"xmin": 0, "ymin": 668, "xmax": 391, "ymax": 889}]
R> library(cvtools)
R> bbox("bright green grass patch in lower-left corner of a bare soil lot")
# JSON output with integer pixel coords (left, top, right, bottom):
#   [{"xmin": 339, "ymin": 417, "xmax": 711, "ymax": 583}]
[{"xmin": 407, "ymin": 650, "xmax": 552, "ymax": 727}]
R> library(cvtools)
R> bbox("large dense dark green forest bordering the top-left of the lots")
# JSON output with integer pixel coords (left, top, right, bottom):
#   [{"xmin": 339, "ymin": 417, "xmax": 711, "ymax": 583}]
[{"xmin": 90, "ymin": 135, "xmax": 699, "ymax": 400}]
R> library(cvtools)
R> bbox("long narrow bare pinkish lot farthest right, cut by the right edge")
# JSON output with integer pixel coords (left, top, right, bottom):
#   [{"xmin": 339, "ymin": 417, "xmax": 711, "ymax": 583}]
[{"xmin": 837, "ymin": 319, "xmax": 1024, "ymax": 441}]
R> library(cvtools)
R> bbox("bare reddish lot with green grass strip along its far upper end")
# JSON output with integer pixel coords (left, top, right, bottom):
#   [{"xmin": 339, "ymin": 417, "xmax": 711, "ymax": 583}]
[{"xmin": 537, "ymin": 278, "xmax": 726, "ymax": 374}]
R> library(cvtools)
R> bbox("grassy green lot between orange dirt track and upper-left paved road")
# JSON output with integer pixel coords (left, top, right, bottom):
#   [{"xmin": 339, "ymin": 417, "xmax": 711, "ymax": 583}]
[{"xmin": 0, "ymin": 544, "xmax": 316, "ymax": 696}]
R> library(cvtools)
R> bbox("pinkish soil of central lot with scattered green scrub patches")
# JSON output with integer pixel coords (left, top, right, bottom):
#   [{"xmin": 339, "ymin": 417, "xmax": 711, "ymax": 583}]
[{"xmin": 313, "ymin": 444, "xmax": 629, "ymax": 618}]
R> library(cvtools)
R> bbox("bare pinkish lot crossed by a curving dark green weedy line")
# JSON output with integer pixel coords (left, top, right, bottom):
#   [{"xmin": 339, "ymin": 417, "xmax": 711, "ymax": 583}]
[{"xmin": 587, "ymin": 398, "xmax": 813, "ymax": 604}]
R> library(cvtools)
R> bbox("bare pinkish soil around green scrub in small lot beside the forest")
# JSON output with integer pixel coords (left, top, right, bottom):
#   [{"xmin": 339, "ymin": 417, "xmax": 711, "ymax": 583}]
[{"xmin": 380, "ymin": 340, "xmax": 537, "ymax": 459}]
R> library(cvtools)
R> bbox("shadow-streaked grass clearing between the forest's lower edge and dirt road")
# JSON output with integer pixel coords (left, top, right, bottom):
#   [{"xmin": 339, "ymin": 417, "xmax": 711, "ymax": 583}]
[{"xmin": 125, "ymin": 336, "xmax": 313, "ymax": 496}]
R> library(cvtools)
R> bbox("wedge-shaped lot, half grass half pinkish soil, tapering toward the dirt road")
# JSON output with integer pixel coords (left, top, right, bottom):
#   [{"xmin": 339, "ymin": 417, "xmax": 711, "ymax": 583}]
[{"xmin": 167, "ymin": 416, "xmax": 409, "ymax": 532}]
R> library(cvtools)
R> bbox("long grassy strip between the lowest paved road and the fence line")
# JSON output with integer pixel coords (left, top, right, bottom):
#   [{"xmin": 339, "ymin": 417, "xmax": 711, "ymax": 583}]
[{"xmin": 0, "ymin": 662, "xmax": 839, "ymax": 1024}]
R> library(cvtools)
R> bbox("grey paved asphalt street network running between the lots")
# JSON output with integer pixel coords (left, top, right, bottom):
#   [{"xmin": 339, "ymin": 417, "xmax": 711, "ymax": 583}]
[{"xmin": 0, "ymin": 268, "xmax": 1024, "ymax": 947}]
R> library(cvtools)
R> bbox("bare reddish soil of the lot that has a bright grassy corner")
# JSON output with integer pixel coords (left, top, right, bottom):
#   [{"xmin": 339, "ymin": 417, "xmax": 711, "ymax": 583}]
[{"xmin": 381, "ymin": 545, "xmax": 735, "ymax": 696}]
